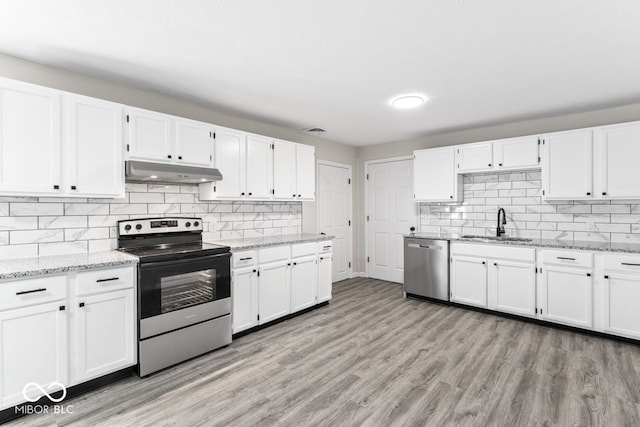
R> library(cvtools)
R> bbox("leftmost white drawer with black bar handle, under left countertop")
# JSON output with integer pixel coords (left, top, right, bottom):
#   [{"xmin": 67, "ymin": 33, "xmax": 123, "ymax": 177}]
[{"xmin": 0, "ymin": 275, "xmax": 67, "ymax": 310}]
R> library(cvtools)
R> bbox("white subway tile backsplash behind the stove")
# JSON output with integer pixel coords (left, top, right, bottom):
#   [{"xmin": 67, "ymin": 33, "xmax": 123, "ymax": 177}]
[{"xmin": 0, "ymin": 183, "xmax": 302, "ymax": 258}]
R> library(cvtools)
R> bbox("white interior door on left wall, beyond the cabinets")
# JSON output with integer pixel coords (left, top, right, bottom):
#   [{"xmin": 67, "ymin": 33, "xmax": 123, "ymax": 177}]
[{"xmin": 318, "ymin": 164, "xmax": 351, "ymax": 282}]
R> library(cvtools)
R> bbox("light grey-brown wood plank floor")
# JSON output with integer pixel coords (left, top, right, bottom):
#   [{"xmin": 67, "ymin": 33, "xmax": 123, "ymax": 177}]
[{"xmin": 7, "ymin": 279, "xmax": 640, "ymax": 426}]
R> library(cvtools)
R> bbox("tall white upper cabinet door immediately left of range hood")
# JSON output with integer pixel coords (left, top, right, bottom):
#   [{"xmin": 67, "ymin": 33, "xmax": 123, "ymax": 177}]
[{"xmin": 65, "ymin": 94, "xmax": 124, "ymax": 197}]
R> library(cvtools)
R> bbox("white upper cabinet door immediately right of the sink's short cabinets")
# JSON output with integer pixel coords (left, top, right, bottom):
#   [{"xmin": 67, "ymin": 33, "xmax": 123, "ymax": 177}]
[{"xmin": 542, "ymin": 130, "xmax": 593, "ymax": 200}]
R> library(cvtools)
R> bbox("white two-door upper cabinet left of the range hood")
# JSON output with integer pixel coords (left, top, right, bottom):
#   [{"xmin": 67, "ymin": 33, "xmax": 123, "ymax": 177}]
[{"xmin": 0, "ymin": 79, "xmax": 124, "ymax": 197}]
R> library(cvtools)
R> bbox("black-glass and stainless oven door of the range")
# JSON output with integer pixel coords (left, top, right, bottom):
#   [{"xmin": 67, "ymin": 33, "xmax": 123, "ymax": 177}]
[{"xmin": 138, "ymin": 253, "xmax": 231, "ymax": 338}]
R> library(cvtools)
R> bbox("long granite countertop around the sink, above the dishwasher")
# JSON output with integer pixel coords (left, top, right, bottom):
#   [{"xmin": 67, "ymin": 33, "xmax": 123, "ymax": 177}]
[{"xmin": 404, "ymin": 233, "xmax": 640, "ymax": 254}]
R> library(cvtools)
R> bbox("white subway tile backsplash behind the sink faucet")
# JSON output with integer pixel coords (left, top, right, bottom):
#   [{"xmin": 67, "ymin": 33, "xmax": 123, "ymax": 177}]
[{"xmin": 420, "ymin": 171, "xmax": 640, "ymax": 243}]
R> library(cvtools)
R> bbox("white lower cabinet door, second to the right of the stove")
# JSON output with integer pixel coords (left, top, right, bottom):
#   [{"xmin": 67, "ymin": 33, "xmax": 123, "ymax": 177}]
[{"xmin": 258, "ymin": 262, "xmax": 291, "ymax": 324}]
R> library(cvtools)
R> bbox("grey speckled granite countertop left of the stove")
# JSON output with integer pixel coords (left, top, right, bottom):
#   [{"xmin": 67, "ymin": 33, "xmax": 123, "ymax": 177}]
[{"xmin": 0, "ymin": 251, "xmax": 138, "ymax": 279}]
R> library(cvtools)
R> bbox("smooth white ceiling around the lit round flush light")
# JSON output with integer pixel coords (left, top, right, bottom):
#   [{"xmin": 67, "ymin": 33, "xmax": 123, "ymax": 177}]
[{"xmin": 0, "ymin": 0, "xmax": 640, "ymax": 146}]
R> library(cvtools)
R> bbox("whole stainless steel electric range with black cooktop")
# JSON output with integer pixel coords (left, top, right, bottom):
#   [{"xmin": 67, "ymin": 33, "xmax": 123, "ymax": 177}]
[{"xmin": 118, "ymin": 218, "xmax": 231, "ymax": 377}]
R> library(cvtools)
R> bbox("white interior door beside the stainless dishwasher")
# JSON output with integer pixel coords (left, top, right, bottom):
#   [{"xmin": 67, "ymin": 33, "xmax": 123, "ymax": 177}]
[{"xmin": 366, "ymin": 160, "xmax": 417, "ymax": 283}]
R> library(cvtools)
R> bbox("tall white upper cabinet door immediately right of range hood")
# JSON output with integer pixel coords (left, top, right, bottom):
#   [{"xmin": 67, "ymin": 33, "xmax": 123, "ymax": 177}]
[{"xmin": 213, "ymin": 128, "xmax": 246, "ymax": 199}]
